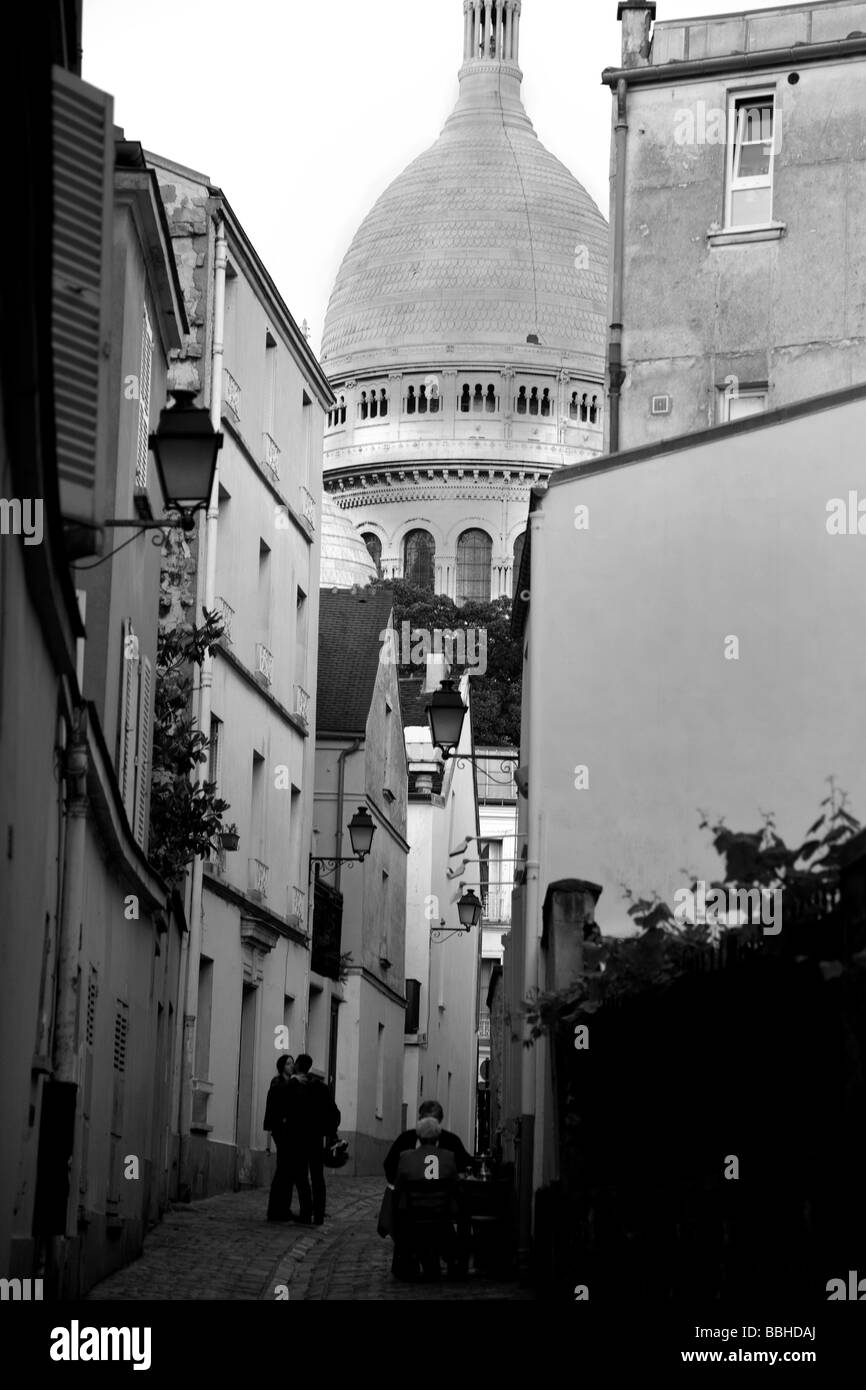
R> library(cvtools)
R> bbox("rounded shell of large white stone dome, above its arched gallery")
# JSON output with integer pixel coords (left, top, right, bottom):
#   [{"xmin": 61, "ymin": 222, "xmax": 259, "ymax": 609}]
[{"xmin": 321, "ymin": 6, "xmax": 607, "ymax": 379}]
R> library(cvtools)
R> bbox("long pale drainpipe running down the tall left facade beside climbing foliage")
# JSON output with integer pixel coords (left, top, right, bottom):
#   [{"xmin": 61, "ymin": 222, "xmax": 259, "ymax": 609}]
[{"xmin": 178, "ymin": 217, "xmax": 227, "ymax": 1182}]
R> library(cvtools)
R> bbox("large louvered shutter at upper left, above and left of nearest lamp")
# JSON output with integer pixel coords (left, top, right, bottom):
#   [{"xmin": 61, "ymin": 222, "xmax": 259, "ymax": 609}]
[{"xmin": 51, "ymin": 68, "xmax": 114, "ymax": 523}]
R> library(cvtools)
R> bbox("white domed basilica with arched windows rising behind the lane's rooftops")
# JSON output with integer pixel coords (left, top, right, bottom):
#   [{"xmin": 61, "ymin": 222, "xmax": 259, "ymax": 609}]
[{"xmin": 321, "ymin": 0, "xmax": 607, "ymax": 603}]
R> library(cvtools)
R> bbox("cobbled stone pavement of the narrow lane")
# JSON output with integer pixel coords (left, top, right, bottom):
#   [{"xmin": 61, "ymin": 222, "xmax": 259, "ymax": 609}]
[{"xmin": 88, "ymin": 1172, "xmax": 532, "ymax": 1302}]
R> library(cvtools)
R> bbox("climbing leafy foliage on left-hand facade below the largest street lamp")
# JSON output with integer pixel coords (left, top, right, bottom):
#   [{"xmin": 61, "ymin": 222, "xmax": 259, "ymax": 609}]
[{"xmin": 149, "ymin": 609, "xmax": 229, "ymax": 883}]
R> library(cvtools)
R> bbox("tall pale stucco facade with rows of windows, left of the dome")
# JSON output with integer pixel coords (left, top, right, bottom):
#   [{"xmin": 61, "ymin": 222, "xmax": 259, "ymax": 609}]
[{"xmin": 149, "ymin": 156, "xmax": 331, "ymax": 1197}]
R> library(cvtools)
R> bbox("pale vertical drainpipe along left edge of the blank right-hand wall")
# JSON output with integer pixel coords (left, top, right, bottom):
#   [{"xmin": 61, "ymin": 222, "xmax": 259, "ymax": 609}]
[{"xmin": 518, "ymin": 498, "xmax": 546, "ymax": 1269}]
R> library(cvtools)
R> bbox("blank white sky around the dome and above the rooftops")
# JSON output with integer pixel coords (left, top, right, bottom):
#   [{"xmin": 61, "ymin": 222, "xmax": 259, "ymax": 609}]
[{"xmin": 82, "ymin": 0, "xmax": 800, "ymax": 350}]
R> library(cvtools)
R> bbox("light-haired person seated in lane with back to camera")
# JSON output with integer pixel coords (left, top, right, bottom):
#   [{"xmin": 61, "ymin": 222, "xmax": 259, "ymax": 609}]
[{"xmin": 392, "ymin": 1115, "xmax": 459, "ymax": 1279}]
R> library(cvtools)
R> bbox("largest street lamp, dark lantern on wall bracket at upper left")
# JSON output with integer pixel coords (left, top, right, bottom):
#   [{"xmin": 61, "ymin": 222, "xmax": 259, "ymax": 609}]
[{"xmin": 103, "ymin": 391, "xmax": 222, "ymax": 543}]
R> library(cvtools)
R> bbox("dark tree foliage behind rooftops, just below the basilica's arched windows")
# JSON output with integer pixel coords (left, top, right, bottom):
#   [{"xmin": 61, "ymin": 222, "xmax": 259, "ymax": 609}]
[{"xmin": 375, "ymin": 580, "xmax": 523, "ymax": 748}]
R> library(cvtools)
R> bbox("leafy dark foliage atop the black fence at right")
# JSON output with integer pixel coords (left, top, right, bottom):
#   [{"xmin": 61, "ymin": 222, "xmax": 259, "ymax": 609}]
[{"xmin": 527, "ymin": 777, "xmax": 860, "ymax": 1045}]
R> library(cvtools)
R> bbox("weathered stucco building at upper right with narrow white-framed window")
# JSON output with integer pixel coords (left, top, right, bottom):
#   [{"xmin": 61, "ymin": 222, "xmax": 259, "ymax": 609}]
[{"xmin": 603, "ymin": 0, "xmax": 866, "ymax": 452}]
